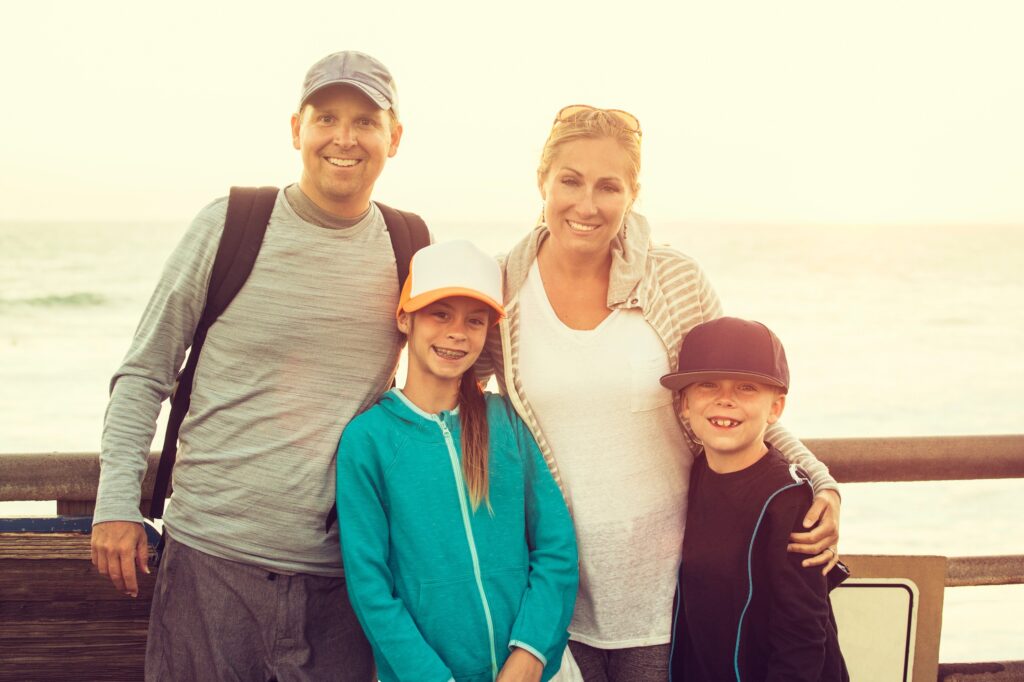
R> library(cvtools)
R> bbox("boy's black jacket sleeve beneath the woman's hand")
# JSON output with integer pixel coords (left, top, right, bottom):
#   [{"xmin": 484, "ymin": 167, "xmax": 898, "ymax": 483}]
[{"xmin": 760, "ymin": 484, "xmax": 828, "ymax": 682}]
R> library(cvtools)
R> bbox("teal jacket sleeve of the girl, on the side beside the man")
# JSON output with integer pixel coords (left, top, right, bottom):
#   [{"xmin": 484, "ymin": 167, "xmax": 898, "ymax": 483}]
[{"xmin": 337, "ymin": 420, "xmax": 452, "ymax": 682}]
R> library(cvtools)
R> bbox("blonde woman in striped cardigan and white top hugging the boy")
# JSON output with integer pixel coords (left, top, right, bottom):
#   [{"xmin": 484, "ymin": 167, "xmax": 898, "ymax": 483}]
[{"xmin": 478, "ymin": 105, "xmax": 839, "ymax": 682}]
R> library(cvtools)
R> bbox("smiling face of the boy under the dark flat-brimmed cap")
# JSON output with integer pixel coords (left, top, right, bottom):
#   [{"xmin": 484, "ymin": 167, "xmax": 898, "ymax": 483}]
[{"xmin": 683, "ymin": 379, "xmax": 785, "ymax": 473}]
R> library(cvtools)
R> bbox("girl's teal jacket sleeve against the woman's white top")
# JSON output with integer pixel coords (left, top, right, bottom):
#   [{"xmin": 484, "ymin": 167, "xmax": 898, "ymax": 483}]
[{"xmin": 509, "ymin": 410, "xmax": 580, "ymax": 667}]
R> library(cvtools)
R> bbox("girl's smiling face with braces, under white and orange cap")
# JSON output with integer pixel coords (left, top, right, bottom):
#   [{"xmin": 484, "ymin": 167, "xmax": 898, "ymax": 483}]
[{"xmin": 398, "ymin": 296, "xmax": 493, "ymax": 390}]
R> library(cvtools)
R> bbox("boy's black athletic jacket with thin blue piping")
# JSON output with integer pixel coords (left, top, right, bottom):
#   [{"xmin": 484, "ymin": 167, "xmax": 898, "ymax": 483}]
[{"xmin": 670, "ymin": 447, "xmax": 849, "ymax": 682}]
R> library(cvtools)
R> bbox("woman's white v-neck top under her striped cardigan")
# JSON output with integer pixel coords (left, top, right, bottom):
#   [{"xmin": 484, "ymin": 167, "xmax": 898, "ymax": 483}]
[{"xmin": 519, "ymin": 261, "xmax": 691, "ymax": 649}]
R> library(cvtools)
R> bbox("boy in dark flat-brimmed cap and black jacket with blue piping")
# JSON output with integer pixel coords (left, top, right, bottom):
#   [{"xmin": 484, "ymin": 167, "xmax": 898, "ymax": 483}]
[{"xmin": 662, "ymin": 317, "xmax": 849, "ymax": 682}]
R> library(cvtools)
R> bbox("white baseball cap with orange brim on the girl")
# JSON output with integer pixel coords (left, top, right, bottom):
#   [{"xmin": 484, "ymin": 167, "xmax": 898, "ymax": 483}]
[{"xmin": 395, "ymin": 241, "xmax": 505, "ymax": 323}]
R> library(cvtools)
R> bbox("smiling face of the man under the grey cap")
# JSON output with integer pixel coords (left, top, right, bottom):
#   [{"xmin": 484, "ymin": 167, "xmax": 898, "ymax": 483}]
[{"xmin": 292, "ymin": 85, "xmax": 401, "ymax": 217}]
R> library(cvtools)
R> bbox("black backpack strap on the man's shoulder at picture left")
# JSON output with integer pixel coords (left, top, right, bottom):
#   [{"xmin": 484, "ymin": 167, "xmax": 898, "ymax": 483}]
[{"xmin": 150, "ymin": 187, "xmax": 278, "ymax": 518}]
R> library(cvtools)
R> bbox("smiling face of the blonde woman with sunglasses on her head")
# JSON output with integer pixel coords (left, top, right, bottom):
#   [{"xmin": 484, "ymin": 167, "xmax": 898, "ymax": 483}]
[{"xmin": 539, "ymin": 137, "xmax": 635, "ymax": 258}]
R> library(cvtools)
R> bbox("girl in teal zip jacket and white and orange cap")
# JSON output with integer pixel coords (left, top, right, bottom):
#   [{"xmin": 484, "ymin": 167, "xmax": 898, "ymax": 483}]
[{"xmin": 337, "ymin": 242, "xmax": 579, "ymax": 682}]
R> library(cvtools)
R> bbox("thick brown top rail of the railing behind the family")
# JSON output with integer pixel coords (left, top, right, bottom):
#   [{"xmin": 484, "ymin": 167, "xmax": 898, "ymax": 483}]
[{"xmin": 0, "ymin": 434, "xmax": 1024, "ymax": 501}]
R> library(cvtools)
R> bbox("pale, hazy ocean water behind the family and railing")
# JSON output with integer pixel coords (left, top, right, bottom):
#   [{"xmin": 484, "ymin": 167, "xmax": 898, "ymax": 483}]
[{"xmin": 0, "ymin": 216, "xmax": 1024, "ymax": 662}]
